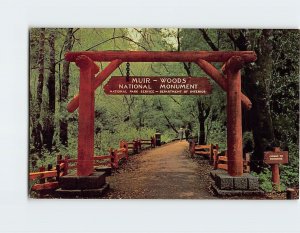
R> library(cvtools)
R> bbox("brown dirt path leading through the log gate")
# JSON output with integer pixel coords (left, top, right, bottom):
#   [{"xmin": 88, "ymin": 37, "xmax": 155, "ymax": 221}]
[{"xmin": 104, "ymin": 141, "xmax": 215, "ymax": 199}]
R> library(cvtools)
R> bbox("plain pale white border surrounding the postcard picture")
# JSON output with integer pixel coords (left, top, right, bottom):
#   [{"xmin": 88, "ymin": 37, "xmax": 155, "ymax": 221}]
[{"xmin": 0, "ymin": 0, "xmax": 300, "ymax": 233}]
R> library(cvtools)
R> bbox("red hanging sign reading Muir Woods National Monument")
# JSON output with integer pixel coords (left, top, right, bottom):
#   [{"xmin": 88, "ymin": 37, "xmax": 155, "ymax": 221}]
[{"xmin": 104, "ymin": 76, "xmax": 212, "ymax": 95}]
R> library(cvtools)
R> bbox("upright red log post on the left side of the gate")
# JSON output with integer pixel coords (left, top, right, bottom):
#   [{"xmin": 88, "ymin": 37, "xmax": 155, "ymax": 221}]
[{"xmin": 76, "ymin": 56, "xmax": 96, "ymax": 176}]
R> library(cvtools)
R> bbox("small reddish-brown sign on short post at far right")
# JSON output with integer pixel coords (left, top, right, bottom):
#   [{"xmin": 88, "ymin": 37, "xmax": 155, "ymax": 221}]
[{"xmin": 264, "ymin": 147, "xmax": 289, "ymax": 191}]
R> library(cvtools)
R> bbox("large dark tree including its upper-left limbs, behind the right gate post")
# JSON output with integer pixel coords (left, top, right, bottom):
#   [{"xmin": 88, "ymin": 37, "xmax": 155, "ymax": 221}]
[{"xmin": 227, "ymin": 29, "xmax": 276, "ymax": 170}]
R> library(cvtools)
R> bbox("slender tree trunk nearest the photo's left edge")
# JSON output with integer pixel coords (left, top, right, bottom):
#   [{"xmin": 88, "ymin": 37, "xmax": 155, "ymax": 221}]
[{"xmin": 32, "ymin": 28, "xmax": 45, "ymax": 151}]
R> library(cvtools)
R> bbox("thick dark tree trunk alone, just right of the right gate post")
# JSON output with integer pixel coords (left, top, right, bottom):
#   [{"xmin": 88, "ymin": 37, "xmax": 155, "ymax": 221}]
[{"xmin": 246, "ymin": 30, "xmax": 275, "ymax": 171}]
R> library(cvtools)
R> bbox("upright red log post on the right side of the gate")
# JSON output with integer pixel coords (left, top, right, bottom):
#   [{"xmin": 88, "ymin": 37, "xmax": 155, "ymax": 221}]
[{"xmin": 225, "ymin": 56, "xmax": 244, "ymax": 176}]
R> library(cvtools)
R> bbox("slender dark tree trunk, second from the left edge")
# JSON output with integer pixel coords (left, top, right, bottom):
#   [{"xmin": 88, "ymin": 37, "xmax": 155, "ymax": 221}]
[{"xmin": 43, "ymin": 31, "xmax": 55, "ymax": 151}]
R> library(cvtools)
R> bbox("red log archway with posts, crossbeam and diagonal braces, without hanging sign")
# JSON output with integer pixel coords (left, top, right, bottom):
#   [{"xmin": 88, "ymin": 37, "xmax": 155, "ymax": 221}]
[{"xmin": 65, "ymin": 51, "xmax": 256, "ymax": 176}]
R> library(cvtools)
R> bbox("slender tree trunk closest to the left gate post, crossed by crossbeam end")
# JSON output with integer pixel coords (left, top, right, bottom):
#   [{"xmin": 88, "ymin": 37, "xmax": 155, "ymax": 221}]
[{"xmin": 59, "ymin": 28, "xmax": 73, "ymax": 146}]
